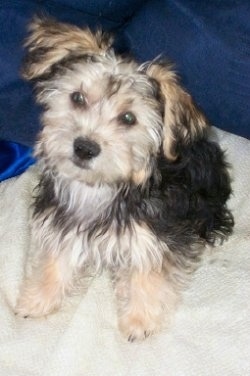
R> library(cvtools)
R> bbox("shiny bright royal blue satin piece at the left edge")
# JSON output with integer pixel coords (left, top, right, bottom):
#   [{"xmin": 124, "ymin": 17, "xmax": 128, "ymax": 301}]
[{"xmin": 0, "ymin": 140, "xmax": 34, "ymax": 182}]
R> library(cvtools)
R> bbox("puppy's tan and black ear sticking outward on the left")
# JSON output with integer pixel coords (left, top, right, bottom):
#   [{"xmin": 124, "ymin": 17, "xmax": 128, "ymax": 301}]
[{"xmin": 22, "ymin": 16, "xmax": 113, "ymax": 80}]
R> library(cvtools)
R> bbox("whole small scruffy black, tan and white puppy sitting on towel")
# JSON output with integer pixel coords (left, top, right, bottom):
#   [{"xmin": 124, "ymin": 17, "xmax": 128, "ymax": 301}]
[{"xmin": 16, "ymin": 17, "xmax": 233, "ymax": 341}]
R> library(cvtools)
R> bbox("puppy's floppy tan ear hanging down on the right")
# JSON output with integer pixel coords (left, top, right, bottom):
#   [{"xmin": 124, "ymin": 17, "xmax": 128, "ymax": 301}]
[{"xmin": 146, "ymin": 63, "xmax": 208, "ymax": 161}]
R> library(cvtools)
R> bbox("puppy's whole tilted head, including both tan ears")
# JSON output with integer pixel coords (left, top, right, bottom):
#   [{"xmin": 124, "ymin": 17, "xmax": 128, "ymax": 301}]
[{"xmin": 23, "ymin": 18, "xmax": 207, "ymax": 185}]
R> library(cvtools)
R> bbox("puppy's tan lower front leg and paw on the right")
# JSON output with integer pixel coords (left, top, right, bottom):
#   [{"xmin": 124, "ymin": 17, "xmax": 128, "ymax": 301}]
[{"xmin": 114, "ymin": 271, "xmax": 178, "ymax": 341}]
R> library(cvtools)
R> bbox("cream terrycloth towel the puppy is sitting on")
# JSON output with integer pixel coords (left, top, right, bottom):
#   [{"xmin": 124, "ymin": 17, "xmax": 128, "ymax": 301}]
[{"xmin": 0, "ymin": 131, "xmax": 250, "ymax": 376}]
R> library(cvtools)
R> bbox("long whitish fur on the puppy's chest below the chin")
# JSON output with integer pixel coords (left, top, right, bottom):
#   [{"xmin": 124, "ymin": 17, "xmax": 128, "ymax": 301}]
[{"xmin": 33, "ymin": 178, "xmax": 167, "ymax": 271}]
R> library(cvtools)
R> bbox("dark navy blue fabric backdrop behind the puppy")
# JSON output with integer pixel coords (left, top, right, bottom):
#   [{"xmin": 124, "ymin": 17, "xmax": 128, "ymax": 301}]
[{"xmin": 0, "ymin": 0, "xmax": 250, "ymax": 181}]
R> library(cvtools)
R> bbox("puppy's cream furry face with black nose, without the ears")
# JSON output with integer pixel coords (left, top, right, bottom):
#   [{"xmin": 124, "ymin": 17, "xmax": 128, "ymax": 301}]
[{"xmin": 33, "ymin": 56, "xmax": 162, "ymax": 184}]
